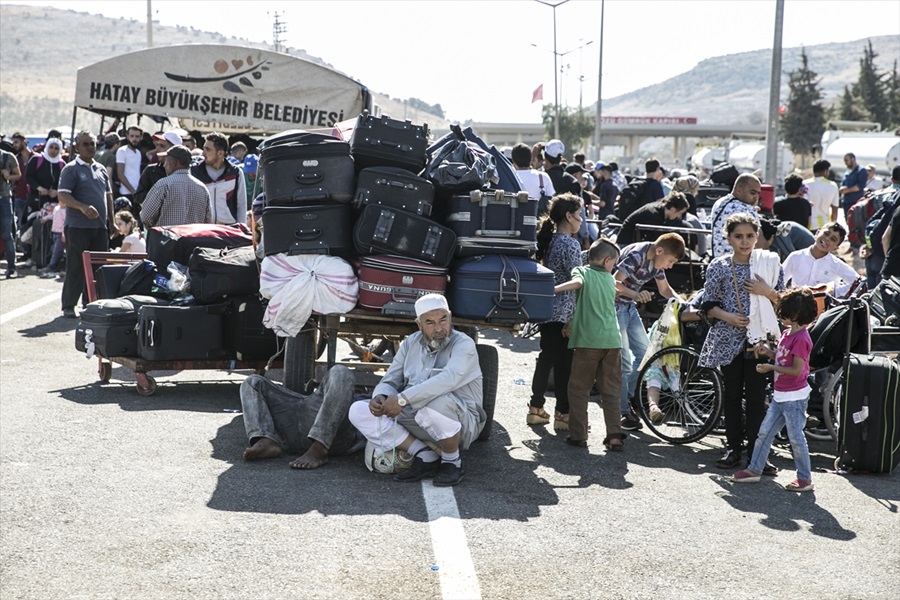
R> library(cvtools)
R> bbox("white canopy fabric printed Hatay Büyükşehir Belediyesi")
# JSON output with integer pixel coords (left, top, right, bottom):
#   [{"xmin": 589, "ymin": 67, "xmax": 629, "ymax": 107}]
[{"xmin": 75, "ymin": 44, "xmax": 372, "ymax": 132}]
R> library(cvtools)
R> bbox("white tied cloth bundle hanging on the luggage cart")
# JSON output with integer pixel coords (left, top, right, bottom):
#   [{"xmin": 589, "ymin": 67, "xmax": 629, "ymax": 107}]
[{"xmin": 259, "ymin": 254, "xmax": 359, "ymax": 337}]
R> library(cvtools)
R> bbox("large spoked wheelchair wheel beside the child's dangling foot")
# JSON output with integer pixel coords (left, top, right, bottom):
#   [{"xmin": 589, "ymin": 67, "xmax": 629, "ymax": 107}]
[{"xmin": 634, "ymin": 346, "xmax": 722, "ymax": 444}]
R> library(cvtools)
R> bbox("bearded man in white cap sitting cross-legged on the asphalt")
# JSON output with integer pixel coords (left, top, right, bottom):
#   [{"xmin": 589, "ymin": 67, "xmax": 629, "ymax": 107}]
[{"xmin": 350, "ymin": 294, "xmax": 487, "ymax": 487}]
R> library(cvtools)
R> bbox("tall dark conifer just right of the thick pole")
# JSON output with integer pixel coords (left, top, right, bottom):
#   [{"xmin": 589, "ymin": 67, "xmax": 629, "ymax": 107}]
[{"xmin": 781, "ymin": 49, "xmax": 825, "ymax": 161}]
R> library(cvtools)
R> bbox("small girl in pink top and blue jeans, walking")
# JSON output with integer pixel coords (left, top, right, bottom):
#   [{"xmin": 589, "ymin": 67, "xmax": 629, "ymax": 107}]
[{"xmin": 731, "ymin": 288, "xmax": 817, "ymax": 492}]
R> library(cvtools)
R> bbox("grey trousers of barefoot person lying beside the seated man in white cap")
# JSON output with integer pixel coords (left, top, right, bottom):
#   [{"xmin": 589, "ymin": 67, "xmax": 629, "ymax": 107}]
[{"xmin": 241, "ymin": 365, "xmax": 366, "ymax": 456}]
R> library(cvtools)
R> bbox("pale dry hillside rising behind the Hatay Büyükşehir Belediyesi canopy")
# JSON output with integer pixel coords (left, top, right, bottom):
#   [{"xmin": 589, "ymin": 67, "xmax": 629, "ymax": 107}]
[{"xmin": 0, "ymin": 4, "xmax": 447, "ymax": 133}]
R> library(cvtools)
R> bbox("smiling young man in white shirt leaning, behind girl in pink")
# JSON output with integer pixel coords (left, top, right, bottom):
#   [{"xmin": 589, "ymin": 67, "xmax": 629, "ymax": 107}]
[{"xmin": 782, "ymin": 223, "xmax": 859, "ymax": 297}]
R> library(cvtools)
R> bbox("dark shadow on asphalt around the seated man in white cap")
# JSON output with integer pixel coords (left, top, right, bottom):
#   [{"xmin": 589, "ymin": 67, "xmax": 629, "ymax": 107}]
[{"xmin": 208, "ymin": 416, "xmax": 559, "ymax": 522}]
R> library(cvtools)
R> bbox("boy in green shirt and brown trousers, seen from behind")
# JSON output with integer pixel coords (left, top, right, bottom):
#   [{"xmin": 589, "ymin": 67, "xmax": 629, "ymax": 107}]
[{"xmin": 553, "ymin": 238, "xmax": 624, "ymax": 451}]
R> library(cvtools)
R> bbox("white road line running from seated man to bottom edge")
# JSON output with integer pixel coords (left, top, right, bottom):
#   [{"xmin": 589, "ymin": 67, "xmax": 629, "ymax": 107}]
[{"xmin": 422, "ymin": 481, "xmax": 481, "ymax": 600}]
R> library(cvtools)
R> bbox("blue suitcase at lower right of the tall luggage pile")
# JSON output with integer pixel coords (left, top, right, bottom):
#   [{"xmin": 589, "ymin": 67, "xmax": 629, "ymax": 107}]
[{"xmin": 447, "ymin": 255, "xmax": 554, "ymax": 323}]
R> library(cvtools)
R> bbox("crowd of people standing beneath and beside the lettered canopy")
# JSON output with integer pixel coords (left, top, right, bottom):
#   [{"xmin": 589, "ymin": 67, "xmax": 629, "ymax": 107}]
[{"xmin": 0, "ymin": 126, "xmax": 261, "ymax": 318}]
